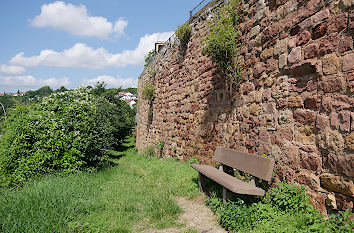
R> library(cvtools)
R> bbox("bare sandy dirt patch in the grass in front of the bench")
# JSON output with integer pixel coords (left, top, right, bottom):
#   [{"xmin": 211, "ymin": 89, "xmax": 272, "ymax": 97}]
[{"xmin": 144, "ymin": 196, "xmax": 226, "ymax": 233}]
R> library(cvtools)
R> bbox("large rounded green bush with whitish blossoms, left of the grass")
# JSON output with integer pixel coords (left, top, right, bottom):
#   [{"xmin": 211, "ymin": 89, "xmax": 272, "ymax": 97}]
[{"xmin": 0, "ymin": 88, "xmax": 134, "ymax": 185}]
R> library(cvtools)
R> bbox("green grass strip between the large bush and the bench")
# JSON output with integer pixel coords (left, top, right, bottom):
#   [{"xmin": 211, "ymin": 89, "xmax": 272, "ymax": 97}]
[{"xmin": 0, "ymin": 139, "xmax": 198, "ymax": 232}]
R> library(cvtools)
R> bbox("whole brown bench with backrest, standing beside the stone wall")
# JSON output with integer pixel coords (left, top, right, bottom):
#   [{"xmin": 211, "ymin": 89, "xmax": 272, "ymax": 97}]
[{"xmin": 192, "ymin": 147, "xmax": 274, "ymax": 202}]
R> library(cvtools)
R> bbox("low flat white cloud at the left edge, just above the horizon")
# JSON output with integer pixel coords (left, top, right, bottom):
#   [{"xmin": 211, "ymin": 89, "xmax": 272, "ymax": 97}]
[{"xmin": 0, "ymin": 75, "xmax": 71, "ymax": 88}]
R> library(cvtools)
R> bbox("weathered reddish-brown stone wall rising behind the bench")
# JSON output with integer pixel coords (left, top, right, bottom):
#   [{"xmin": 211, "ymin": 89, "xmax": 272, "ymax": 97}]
[{"xmin": 137, "ymin": 0, "xmax": 354, "ymax": 212}]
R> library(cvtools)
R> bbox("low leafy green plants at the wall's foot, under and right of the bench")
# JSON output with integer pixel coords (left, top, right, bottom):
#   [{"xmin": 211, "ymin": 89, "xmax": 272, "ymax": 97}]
[{"xmin": 206, "ymin": 183, "xmax": 353, "ymax": 233}]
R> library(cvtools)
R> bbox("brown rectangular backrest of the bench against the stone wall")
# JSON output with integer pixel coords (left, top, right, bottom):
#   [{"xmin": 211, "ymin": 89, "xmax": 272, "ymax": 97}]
[{"xmin": 214, "ymin": 147, "xmax": 274, "ymax": 181}]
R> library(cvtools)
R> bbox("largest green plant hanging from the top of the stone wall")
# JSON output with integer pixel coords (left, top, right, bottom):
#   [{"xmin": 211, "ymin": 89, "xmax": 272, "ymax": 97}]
[{"xmin": 203, "ymin": 0, "xmax": 242, "ymax": 83}]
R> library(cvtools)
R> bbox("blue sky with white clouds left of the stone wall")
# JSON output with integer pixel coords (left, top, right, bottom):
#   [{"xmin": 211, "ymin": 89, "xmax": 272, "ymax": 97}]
[{"xmin": 0, "ymin": 0, "xmax": 201, "ymax": 93}]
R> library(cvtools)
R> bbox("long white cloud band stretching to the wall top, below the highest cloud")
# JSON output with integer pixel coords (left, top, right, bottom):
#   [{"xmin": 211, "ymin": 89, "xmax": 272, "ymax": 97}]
[{"xmin": 10, "ymin": 32, "xmax": 173, "ymax": 69}]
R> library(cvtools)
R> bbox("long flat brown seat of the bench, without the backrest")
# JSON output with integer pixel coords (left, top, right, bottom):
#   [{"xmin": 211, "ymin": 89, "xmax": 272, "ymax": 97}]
[{"xmin": 192, "ymin": 164, "xmax": 265, "ymax": 196}]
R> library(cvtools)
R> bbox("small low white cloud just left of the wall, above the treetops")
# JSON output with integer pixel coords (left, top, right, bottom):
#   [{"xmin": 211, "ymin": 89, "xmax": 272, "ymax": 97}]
[{"xmin": 82, "ymin": 75, "xmax": 138, "ymax": 88}]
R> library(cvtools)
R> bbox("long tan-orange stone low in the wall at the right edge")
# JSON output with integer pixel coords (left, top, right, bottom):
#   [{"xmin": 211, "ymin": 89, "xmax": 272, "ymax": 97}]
[{"xmin": 320, "ymin": 173, "xmax": 354, "ymax": 197}]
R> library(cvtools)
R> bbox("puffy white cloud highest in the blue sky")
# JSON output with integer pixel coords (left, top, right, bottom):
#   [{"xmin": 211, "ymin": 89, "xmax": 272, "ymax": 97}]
[{"xmin": 30, "ymin": 1, "xmax": 128, "ymax": 39}]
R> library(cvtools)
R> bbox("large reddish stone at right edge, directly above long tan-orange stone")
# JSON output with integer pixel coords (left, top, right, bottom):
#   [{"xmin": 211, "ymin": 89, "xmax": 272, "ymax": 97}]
[{"xmin": 325, "ymin": 154, "xmax": 354, "ymax": 178}]
